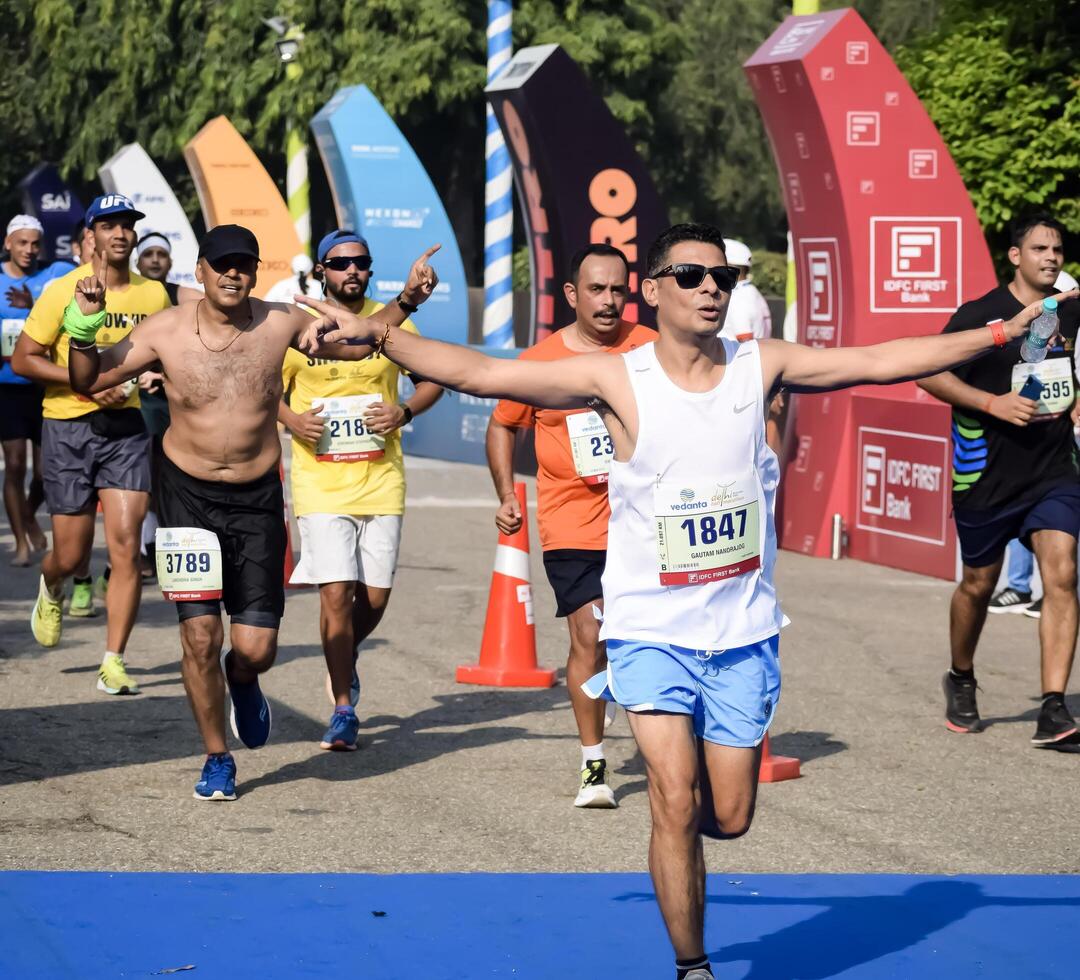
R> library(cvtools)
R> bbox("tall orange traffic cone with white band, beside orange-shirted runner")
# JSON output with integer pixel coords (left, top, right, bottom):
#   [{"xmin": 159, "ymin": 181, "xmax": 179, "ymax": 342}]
[{"xmin": 457, "ymin": 483, "xmax": 555, "ymax": 687}]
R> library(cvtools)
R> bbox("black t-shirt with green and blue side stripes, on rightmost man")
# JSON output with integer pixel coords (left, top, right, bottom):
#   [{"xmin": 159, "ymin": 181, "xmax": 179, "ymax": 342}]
[{"xmin": 944, "ymin": 286, "xmax": 1080, "ymax": 513}]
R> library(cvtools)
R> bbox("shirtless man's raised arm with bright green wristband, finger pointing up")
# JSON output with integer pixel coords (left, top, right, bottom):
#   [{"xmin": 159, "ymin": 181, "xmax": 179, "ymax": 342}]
[{"xmin": 64, "ymin": 254, "xmax": 167, "ymax": 394}]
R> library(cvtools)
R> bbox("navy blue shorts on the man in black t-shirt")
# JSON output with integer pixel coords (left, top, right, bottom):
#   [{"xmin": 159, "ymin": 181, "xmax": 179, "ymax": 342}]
[{"xmin": 954, "ymin": 483, "xmax": 1080, "ymax": 568}]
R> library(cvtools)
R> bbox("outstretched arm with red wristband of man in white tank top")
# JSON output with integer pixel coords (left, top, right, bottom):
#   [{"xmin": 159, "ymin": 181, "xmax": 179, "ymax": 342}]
[{"xmin": 760, "ymin": 290, "xmax": 1080, "ymax": 391}]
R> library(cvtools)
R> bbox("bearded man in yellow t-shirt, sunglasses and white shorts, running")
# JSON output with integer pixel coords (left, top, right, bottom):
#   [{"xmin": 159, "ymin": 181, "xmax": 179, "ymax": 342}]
[{"xmin": 278, "ymin": 230, "xmax": 443, "ymax": 750}]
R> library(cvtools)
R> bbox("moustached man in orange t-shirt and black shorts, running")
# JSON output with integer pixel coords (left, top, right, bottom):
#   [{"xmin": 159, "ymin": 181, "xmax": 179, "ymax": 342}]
[{"xmin": 487, "ymin": 244, "xmax": 657, "ymax": 809}]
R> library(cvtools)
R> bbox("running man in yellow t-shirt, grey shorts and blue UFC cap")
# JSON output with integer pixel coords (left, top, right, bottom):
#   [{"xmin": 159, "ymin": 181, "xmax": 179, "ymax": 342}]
[{"xmin": 12, "ymin": 194, "xmax": 170, "ymax": 694}]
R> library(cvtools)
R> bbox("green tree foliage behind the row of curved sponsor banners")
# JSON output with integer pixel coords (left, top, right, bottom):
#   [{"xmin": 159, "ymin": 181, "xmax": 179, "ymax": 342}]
[{"xmin": 0, "ymin": 0, "xmax": 1080, "ymax": 279}]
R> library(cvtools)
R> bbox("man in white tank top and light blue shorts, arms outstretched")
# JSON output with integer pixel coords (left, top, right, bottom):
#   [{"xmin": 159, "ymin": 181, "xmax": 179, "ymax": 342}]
[{"xmin": 300, "ymin": 225, "xmax": 1076, "ymax": 980}]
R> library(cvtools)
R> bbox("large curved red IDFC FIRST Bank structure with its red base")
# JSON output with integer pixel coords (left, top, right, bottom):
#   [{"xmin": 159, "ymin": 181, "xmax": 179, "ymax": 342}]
[{"xmin": 743, "ymin": 10, "xmax": 996, "ymax": 578}]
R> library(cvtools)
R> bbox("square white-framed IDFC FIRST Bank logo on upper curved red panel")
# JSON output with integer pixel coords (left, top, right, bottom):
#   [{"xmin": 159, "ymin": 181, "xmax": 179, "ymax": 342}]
[{"xmin": 870, "ymin": 217, "xmax": 963, "ymax": 313}]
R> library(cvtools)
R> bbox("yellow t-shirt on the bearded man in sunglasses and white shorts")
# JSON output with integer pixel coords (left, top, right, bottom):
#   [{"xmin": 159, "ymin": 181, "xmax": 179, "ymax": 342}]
[{"xmin": 282, "ymin": 299, "xmax": 419, "ymax": 516}]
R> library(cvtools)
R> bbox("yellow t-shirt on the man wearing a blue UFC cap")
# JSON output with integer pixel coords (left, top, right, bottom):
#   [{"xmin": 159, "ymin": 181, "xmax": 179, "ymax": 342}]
[{"xmin": 24, "ymin": 264, "xmax": 172, "ymax": 418}]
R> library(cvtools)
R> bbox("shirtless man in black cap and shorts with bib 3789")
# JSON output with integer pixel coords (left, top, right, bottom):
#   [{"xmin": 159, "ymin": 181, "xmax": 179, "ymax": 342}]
[{"xmin": 64, "ymin": 225, "xmax": 435, "ymax": 800}]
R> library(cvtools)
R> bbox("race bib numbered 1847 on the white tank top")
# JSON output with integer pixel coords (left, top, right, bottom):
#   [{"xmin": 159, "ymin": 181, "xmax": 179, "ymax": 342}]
[{"xmin": 653, "ymin": 476, "xmax": 761, "ymax": 586}]
